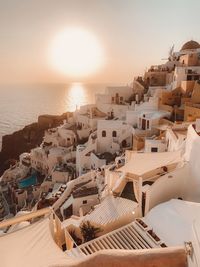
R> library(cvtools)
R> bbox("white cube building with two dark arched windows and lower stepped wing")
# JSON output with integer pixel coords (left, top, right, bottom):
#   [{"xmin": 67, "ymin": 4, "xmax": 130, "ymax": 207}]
[{"xmin": 76, "ymin": 120, "xmax": 133, "ymax": 175}]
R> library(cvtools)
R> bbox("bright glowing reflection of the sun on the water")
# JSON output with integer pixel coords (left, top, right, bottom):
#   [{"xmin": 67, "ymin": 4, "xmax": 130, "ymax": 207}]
[{"xmin": 65, "ymin": 83, "xmax": 87, "ymax": 111}]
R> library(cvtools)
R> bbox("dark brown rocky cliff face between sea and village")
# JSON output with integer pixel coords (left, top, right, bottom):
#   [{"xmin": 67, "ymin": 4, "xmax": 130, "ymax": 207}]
[{"xmin": 0, "ymin": 113, "xmax": 70, "ymax": 176}]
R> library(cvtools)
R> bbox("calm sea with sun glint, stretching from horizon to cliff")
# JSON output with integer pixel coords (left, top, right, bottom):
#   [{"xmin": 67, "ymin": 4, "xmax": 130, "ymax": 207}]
[{"xmin": 0, "ymin": 83, "xmax": 106, "ymax": 148}]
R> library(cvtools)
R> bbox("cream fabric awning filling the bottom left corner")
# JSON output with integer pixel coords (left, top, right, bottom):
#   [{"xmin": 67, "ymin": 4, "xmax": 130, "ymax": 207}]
[{"xmin": 0, "ymin": 218, "xmax": 71, "ymax": 267}]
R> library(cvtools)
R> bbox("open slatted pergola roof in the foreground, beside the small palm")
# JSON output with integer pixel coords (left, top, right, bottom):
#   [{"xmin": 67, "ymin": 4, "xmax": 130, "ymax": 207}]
[{"xmin": 66, "ymin": 219, "xmax": 167, "ymax": 257}]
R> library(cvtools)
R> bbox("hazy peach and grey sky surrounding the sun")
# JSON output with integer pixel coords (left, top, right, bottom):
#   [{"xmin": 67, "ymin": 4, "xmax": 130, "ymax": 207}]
[{"xmin": 0, "ymin": 0, "xmax": 200, "ymax": 83}]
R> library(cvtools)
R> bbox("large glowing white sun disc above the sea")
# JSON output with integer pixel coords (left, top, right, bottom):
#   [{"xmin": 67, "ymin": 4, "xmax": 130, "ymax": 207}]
[{"xmin": 50, "ymin": 27, "xmax": 104, "ymax": 77}]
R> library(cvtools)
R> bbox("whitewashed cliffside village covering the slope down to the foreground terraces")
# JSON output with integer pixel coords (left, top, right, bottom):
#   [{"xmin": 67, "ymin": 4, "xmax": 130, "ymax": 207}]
[{"xmin": 0, "ymin": 40, "xmax": 200, "ymax": 267}]
